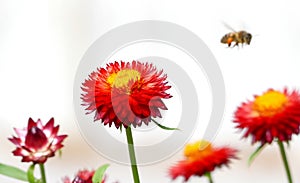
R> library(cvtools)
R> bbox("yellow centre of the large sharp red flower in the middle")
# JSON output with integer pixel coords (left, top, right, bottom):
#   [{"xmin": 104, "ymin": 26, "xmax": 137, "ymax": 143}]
[{"xmin": 107, "ymin": 69, "xmax": 141, "ymax": 89}]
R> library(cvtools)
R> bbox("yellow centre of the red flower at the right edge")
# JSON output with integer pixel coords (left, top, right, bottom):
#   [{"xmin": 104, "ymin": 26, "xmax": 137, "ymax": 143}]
[{"xmin": 253, "ymin": 91, "xmax": 288, "ymax": 116}]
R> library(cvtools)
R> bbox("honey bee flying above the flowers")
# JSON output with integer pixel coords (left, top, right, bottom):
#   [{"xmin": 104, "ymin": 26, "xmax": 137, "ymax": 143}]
[{"xmin": 221, "ymin": 24, "xmax": 252, "ymax": 47}]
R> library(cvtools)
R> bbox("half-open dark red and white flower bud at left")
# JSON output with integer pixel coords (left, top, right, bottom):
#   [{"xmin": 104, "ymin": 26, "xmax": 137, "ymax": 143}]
[{"xmin": 9, "ymin": 118, "xmax": 67, "ymax": 163}]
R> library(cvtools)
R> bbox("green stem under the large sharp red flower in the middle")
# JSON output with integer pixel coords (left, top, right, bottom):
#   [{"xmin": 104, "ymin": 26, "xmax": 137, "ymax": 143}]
[{"xmin": 126, "ymin": 126, "xmax": 140, "ymax": 183}]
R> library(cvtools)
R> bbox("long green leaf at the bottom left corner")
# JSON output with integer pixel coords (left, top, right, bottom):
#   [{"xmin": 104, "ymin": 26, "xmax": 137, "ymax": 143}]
[{"xmin": 0, "ymin": 163, "xmax": 28, "ymax": 182}]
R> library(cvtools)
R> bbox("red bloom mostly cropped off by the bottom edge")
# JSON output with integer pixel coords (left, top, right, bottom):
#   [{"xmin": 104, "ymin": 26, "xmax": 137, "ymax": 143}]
[{"xmin": 63, "ymin": 170, "xmax": 105, "ymax": 183}]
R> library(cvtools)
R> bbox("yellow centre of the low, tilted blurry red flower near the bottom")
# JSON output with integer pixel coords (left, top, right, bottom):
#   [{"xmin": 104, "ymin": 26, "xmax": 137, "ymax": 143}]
[{"xmin": 184, "ymin": 140, "xmax": 212, "ymax": 160}]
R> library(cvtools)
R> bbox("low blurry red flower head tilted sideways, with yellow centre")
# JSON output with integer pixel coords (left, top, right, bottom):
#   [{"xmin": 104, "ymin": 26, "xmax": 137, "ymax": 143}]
[{"xmin": 169, "ymin": 141, "xmax": 237, "ymax": 181}]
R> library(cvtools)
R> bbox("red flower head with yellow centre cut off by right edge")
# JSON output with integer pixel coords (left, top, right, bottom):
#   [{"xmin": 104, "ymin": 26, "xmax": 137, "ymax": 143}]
[{"xmin": 234, "ymin": 89, "xmax": 300, "ymax": 144}]
